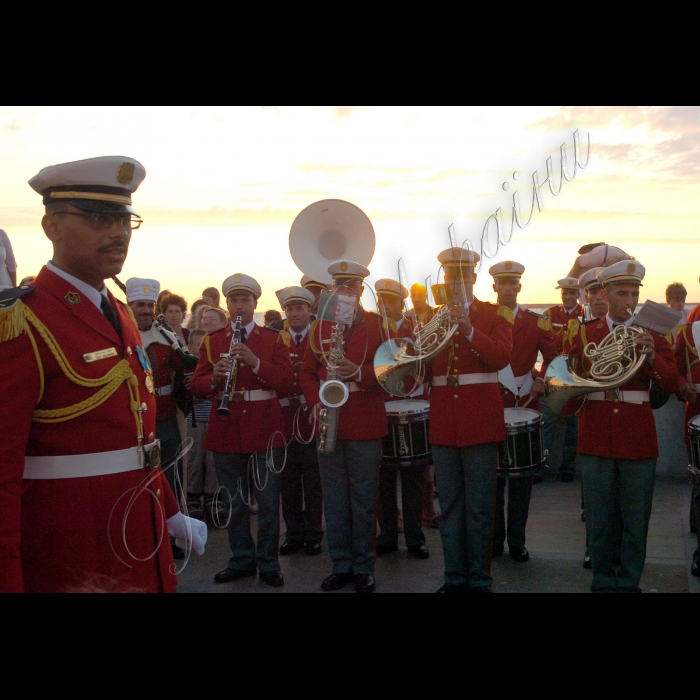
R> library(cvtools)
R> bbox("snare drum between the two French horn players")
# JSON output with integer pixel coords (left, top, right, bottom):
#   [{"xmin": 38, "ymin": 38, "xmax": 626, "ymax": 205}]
[{"xmin": 498, "ymin": 408, "xmax": 547, "ymax": 478}]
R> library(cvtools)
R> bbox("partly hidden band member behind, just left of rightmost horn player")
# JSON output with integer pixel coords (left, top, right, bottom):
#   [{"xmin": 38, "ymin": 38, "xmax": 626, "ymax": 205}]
[{"xmin": 535, "ymin": 277, "xmax": 583, "ymax": 483}]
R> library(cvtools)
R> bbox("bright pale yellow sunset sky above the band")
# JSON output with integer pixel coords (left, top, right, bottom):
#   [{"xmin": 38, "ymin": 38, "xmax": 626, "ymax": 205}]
[{"xmin": 0, "ymin": 107, "xmax": 700, "ymax": 311}]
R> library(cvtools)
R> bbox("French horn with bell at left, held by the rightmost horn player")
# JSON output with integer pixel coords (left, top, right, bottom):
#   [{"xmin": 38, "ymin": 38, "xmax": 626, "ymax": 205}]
[{"xmin": 544, "ymin": 322, "xmax": 648, "ymax": 413}]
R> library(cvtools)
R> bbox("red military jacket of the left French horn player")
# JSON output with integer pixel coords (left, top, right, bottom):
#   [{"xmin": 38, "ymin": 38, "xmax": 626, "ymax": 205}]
[{"xmin": 430, "ymin": 298, "xmax": 513, "ymax": 447}]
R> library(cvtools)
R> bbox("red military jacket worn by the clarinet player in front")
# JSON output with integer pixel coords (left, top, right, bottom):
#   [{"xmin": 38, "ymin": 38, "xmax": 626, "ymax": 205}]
[{"xmin": 192, "ymin": 323, "xmax": 294, "ymax": 454}]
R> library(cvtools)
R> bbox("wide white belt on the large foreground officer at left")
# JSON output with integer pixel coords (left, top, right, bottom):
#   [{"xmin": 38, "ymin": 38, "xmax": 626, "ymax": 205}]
[{"xmin": 24, "ymin": 440, "xmax": 160, "ymax": 479}]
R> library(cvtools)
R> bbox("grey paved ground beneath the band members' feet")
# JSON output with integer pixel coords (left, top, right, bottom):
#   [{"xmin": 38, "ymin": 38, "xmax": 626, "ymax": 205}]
[{"xmin": 178, "ymin": 473, "xmax": 700, "ymax": 593}]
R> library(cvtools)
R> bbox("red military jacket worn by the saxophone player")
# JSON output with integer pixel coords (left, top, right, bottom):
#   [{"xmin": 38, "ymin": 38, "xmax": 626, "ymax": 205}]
[{"xmin": 299, "ymin": 308, "xmax": 395, "ymax": 440}]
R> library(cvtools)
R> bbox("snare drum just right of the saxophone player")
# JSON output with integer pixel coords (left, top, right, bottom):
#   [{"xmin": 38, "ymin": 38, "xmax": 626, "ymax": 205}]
[{"xmin": 382, "ymin": 399, "xmax": 433, "ymax": 467}]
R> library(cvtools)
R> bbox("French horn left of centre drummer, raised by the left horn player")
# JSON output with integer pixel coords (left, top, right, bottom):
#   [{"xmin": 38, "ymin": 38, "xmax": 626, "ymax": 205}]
[{"xmin": 374, "ymin": 304, "xmax": 458, "ymax": 396}]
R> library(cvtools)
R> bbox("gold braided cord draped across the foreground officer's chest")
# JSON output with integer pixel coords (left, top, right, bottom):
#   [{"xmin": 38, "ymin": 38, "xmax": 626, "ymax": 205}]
[{"xmin": 24, "ymin": 307, "xmax": 140, "ymax": 429}]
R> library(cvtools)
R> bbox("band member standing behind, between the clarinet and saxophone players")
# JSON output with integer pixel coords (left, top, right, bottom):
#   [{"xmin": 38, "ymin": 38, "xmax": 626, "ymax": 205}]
[{"xmin": 275, "ymin": 287, "xmax": 323, "ymax": 555}]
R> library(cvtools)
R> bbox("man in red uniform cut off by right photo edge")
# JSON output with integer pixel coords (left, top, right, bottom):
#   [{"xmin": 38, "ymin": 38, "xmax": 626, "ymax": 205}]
[{"xmin": 675, "ymin": 321, "xmax": 700, "ymax": 576}]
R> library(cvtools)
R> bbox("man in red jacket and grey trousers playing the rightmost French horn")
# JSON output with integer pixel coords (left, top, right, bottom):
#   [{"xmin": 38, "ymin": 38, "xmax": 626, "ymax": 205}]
[{"xmin": 569, "ymin": 260, "xmax": 683, "ymax": 593}]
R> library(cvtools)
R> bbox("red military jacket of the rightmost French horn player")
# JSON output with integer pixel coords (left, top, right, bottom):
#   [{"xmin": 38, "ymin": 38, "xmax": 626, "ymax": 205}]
[{"xmin": 569, "ymin": 316, "xmax": 683, "ymax": 459}]
